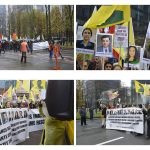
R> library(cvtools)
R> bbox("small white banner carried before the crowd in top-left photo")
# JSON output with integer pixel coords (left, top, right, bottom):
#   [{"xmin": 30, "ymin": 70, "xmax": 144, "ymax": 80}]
[{"xmin": 33, "ymin": 41, "xmax": 49, "ymax": 50}]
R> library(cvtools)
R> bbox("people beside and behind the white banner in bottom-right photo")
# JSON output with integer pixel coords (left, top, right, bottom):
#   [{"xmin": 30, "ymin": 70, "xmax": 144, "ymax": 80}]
[{"xmin": 79, "ymin": 102, "xmax": 150, "ymax": 139}]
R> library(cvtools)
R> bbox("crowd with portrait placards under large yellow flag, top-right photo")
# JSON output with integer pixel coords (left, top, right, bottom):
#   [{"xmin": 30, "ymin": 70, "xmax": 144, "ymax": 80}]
[{"xmin": 76, "ymin": 5, "xmax": 150, "ymax": 70}]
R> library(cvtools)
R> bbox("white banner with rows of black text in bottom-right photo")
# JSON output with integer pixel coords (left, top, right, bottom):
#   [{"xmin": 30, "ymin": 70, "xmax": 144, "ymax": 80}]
[{"xmin": 106, "ymin": 108, "xmax": 144, "ymax": 134}]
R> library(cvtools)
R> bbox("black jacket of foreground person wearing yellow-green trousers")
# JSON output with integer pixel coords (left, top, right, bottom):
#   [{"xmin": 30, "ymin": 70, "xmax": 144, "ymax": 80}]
[{"xmin": 45, "ymin": 80, "xmax": 74, "ymax": 120}]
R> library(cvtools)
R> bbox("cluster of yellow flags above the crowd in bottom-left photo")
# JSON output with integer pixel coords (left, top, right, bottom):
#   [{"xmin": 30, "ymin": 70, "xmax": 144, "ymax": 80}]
[{"xmin": 3, "ymin": 80, "xmax": 46, "ymax": 102}]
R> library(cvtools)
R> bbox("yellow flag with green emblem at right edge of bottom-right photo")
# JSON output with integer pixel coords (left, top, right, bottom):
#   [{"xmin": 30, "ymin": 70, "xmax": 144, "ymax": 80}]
[{"xmin": 134, "ymin": 80, "xmax": 150, "ymax": 96}]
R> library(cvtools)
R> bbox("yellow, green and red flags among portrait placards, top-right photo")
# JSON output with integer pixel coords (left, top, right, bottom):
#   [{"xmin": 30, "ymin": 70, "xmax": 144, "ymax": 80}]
[{"xmin": 84, "ymin": 5, "xmax": 135, "ymax": 66}]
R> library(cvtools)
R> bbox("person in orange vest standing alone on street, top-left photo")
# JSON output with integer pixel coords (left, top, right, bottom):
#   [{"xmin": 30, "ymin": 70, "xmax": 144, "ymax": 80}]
[{"xmin": 20, "ymin": 40, "xmax": 29, "ymax": 63}]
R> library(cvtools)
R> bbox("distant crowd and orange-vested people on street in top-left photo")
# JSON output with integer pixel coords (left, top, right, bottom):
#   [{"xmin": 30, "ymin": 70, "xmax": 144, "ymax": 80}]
[{"xmin": 0, "ymin": 40, "xmax": 64, "ymax": 63}]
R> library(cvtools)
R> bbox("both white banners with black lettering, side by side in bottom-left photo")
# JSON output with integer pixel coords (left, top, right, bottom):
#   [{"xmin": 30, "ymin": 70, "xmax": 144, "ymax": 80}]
[{"xmin": 0, "ymin": 108, "xmax": 44, "ymax": 145}]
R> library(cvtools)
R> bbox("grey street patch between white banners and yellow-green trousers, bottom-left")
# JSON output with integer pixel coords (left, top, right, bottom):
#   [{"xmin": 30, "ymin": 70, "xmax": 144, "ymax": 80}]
[{"xmin": 18, "ymin": 131, "xmax": 42, "ymax": 145}]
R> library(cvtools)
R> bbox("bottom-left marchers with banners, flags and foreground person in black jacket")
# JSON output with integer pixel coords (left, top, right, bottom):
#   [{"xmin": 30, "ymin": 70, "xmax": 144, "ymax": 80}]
[{"xmin": 0, "ymin": 80, "xmax": 74, "ymax": 145}]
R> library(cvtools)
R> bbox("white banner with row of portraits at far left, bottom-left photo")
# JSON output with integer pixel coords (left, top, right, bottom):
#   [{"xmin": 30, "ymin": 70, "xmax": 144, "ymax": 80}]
[{"xmin": 0, "ymin": 108, "xmax": 29, "ymax": 145}]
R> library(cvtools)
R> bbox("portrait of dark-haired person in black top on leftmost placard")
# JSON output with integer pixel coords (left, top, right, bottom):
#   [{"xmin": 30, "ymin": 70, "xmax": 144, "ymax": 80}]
[{"xmin": 76, "ymin": 28, "xmax": 94, "ymax": 50}]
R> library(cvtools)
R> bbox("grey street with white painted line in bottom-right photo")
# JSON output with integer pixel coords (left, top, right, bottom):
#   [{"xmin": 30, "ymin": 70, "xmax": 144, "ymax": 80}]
[{"xmin": 76, "ymin": 119, "xmax": 150, "ymax": 145}]
